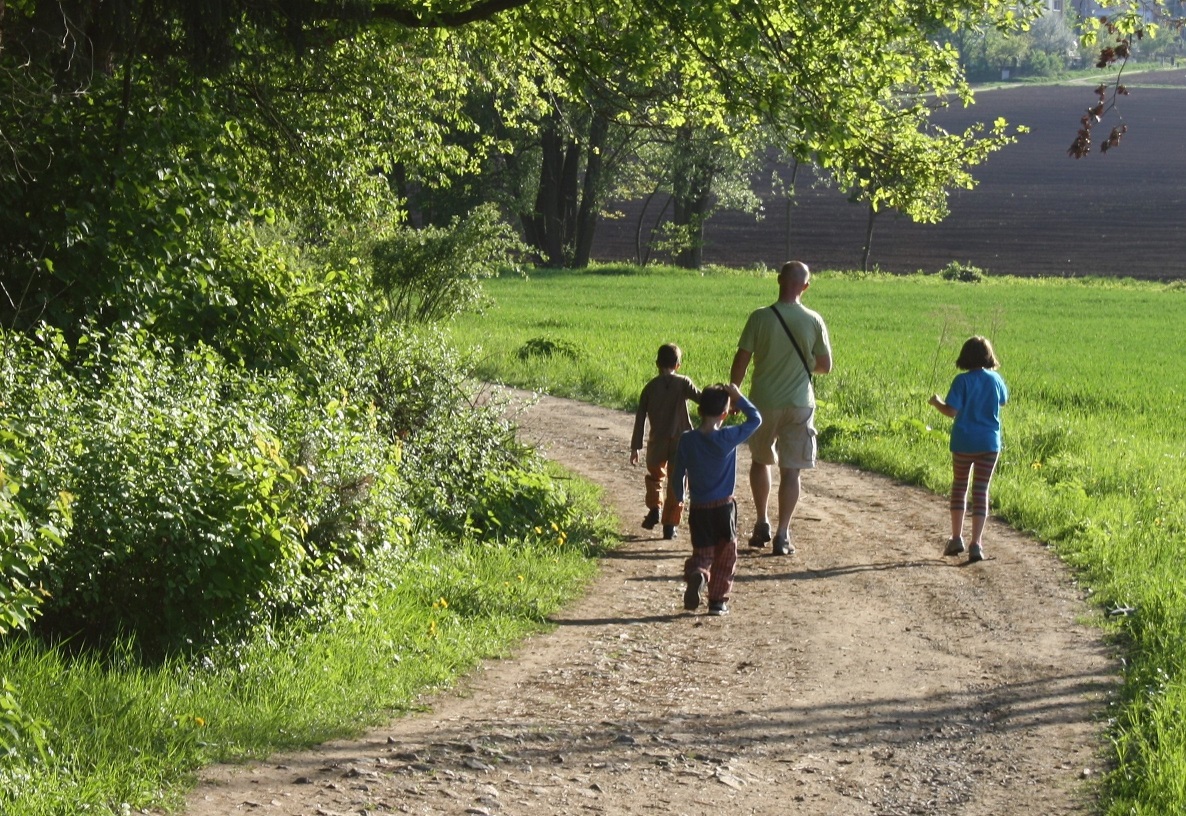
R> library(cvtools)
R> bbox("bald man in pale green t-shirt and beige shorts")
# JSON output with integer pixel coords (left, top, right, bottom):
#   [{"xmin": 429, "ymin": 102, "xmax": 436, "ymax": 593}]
[{"xmin": 729, "ymin": 261, "xmax": 831, "ymax": 555}]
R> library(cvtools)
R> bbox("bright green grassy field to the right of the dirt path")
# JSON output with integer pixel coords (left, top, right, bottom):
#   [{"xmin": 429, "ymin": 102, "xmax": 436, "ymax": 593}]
[{"xmin": 453, "ymin": 267, "xmax": 1186, "ymax": 815}]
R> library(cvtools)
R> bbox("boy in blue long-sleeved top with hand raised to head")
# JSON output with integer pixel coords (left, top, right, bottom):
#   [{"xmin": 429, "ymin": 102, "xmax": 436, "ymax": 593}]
[{"xmin": 671, "ymin": 383, "xmax": 761, "ymax": 614}]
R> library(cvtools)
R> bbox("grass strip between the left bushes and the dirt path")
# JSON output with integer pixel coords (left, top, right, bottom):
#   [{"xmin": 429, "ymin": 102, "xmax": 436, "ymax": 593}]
[{"xmin": 0, "ymin": 470, "xmax": 616, "ymax": 816}]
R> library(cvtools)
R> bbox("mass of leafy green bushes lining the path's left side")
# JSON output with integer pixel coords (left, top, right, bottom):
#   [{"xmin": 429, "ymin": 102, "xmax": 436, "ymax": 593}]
[{"xmin": 0, "ymin": 313, "xmax": 555, "ymax": 656}]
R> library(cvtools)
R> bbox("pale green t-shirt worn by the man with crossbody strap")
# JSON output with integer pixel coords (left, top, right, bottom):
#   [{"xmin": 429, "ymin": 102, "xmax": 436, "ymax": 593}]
[{"xmin": 738, "ymin": 302, "xmax": 831, "ymax": 410}]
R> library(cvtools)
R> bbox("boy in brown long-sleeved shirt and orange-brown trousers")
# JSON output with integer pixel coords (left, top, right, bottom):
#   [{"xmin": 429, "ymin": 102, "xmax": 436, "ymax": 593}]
[{"xmin": 630, "ymin": 343, "xmax": 700, "ymax": 540}]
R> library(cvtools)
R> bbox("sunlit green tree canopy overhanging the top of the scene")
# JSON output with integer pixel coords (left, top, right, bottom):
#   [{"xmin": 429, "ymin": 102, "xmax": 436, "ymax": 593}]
[{"xmin": 0, "ymin": 0, "xmax": 1024, "ymax": 308}]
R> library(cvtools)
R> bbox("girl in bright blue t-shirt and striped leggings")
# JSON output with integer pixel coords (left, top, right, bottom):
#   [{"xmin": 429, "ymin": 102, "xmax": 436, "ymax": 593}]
[{"xmin": 930, "ymin": 336, "xmax": 1009, "ymax": 563}]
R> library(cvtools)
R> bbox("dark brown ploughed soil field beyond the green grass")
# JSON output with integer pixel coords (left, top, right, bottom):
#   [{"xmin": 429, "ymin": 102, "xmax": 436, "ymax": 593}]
[{"xmin": 593, "ymin": 70, "xmax": 1186, "ymax": 279}]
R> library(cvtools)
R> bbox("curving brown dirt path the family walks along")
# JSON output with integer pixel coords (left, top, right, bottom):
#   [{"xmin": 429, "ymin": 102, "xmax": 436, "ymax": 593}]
[{"xmin": 180, "ymin": 397, "xmax": 1116, "ymax": 816}]
